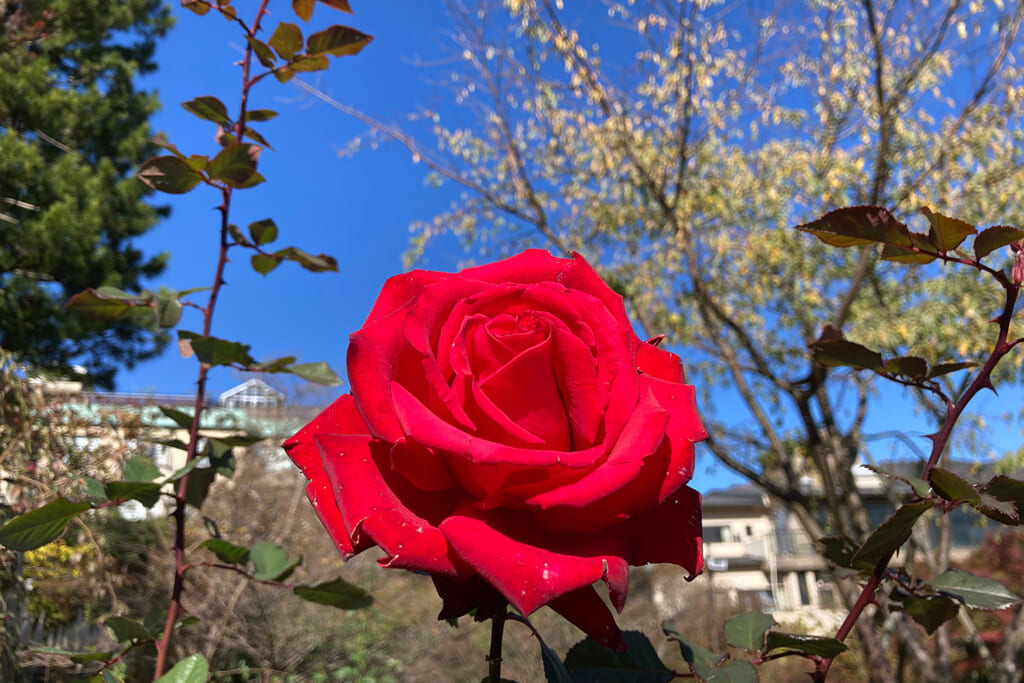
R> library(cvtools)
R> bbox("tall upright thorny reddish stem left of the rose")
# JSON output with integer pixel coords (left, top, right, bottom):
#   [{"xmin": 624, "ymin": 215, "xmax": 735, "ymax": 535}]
[{"xmin": 153, "ymin": 0, "xmax": 270, "ymax": 680}]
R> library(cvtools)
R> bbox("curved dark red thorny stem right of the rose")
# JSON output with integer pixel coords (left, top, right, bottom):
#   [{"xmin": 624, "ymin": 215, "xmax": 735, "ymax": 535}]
[{"xmin": 811, "ymin": 262, "xmax": 1022, "ymax": 682}]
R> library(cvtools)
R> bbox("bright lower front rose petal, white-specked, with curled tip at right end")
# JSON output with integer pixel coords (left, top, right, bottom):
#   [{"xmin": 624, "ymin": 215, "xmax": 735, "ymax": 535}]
[{"xmin": 440, "ymin": 515, "xmax": 629, "ymax": 615}]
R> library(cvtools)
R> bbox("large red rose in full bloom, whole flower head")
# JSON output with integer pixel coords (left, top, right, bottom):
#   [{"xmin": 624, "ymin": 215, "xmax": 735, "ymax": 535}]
[{"xmin": 285, "ymin": 250, "xmax": 706, "ymax": 646}]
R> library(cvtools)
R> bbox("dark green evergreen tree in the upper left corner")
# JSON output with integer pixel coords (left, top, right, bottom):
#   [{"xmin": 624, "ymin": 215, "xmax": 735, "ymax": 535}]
[{"xmin": 0, "ymin": 0, "xmax": 171, "ymax": 387}]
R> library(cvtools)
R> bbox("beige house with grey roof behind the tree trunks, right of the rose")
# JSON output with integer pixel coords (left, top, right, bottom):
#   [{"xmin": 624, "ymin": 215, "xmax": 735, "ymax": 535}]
[{"xmin": 699, "ymin": 463, "xmax": 991, "ymax": 624}]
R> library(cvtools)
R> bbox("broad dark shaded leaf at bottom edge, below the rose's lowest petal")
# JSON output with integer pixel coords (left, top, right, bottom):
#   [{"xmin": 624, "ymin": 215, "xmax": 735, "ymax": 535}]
[{"xmin": 565, "ymin": 631, "xmax": 675, "ymax": 683}]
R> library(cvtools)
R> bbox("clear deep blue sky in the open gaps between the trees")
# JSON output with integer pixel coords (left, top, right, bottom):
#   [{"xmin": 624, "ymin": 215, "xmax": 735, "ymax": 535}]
[{"xmin": 118, "ymin": 0, "xmax": 1019, "ymax": 490}]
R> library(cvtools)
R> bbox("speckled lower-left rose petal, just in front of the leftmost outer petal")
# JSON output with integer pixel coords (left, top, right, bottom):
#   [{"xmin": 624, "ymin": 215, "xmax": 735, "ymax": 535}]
[{"xmin": 316, "ymin": 434, "xmax": 460, "ymax": 575}]
